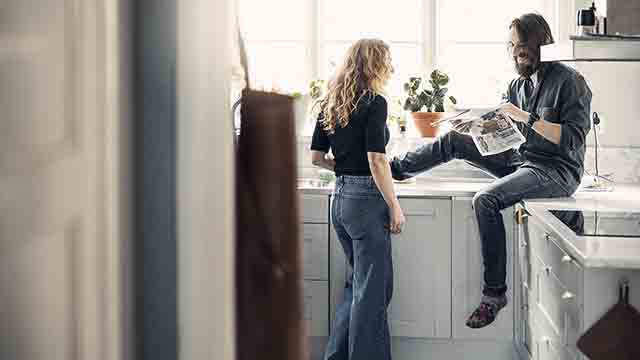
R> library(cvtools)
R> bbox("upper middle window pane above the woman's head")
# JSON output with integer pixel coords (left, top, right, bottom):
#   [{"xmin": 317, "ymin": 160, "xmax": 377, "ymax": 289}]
[{"xmin": 320, "ymin": 0, "xmax": 424, "ymax": 42}]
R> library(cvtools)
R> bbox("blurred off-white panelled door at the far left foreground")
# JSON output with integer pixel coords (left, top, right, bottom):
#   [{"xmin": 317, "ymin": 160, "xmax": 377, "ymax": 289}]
[{"xmin": 0, "ymin": 0, "xmax": 129, "ymax": 360}]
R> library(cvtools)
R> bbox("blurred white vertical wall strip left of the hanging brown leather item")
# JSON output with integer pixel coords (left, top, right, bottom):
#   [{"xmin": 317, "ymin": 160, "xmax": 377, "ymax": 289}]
[{"xmin": 177, "ymin": 0, "xmax": 235, "ymax": 360}]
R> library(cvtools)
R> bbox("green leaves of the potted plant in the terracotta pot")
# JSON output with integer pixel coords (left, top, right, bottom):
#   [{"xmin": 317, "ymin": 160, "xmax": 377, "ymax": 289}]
[{"xmin": 404, "ymin": 70, "xmax": 458, "ymax": 112}]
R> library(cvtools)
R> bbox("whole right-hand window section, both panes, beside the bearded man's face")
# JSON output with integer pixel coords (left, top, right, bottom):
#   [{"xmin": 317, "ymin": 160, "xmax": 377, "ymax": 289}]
[{"xmin": 436, "ymin": 0, "xmax": 564, "ymax": 105}]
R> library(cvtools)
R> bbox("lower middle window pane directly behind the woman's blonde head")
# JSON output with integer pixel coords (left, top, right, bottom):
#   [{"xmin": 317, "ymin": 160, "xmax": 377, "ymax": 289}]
[{"xmin": 321, "ymin": 43, "xmax": 424, "ymax": 96}]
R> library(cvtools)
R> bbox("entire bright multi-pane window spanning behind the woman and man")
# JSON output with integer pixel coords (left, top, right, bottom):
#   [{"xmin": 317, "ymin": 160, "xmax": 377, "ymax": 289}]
[{"xmin": 238, "ymin": 0, "xmax": 572, "ymax": 105}]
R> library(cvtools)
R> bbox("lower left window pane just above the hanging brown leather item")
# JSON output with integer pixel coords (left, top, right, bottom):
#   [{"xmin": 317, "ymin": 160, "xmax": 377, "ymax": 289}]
[{"xmin": 247, "ymin": 42, "xmax": 309, "ymax": 93}]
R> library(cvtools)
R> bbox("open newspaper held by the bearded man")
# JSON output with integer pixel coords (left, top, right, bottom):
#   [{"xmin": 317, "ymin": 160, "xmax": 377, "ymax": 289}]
[{"xmin": 445, "ymin": 107, "xmax": 526, "ymax": 156}]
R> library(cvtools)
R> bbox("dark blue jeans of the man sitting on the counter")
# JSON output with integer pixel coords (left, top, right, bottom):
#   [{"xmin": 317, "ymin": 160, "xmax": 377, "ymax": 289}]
[{"xmin": 391, "ymin": 132, "xmax": 576, "ymax": 296}]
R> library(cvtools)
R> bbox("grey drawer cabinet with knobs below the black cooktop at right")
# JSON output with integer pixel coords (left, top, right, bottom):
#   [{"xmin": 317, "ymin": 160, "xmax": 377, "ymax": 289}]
[{"xmin": 515, "ymin": 205, "xmax": 640, "ymax": 360}]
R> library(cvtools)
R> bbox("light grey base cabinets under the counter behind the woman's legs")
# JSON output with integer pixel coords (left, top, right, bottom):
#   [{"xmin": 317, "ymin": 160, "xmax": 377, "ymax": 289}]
[{"xmin": 302, "ymin": 191, "xmax": 515, "ymax": 360}]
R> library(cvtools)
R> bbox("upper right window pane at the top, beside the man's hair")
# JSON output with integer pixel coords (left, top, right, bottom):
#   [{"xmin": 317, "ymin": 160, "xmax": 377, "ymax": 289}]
[{"xmin": 438, "ymin": 0, "xmax": 548, "ymax": 42}]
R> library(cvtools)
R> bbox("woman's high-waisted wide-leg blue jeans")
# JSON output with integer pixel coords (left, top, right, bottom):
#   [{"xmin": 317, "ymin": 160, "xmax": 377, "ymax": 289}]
[{"xmin": 325, "ymin": 176, "xmax": 393, "ymax": 360}]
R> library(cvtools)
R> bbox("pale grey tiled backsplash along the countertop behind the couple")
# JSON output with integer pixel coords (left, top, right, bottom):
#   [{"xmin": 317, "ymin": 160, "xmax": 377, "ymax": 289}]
[{"xmin": 298, "ymin": 137, "xmax": 640, "ymax": 183}]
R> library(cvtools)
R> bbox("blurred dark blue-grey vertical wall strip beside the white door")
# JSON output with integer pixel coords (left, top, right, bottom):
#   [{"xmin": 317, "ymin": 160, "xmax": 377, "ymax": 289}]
[{"xmin": 134, "ymin": 0, "xmax": 178, "ymax": 360}]
